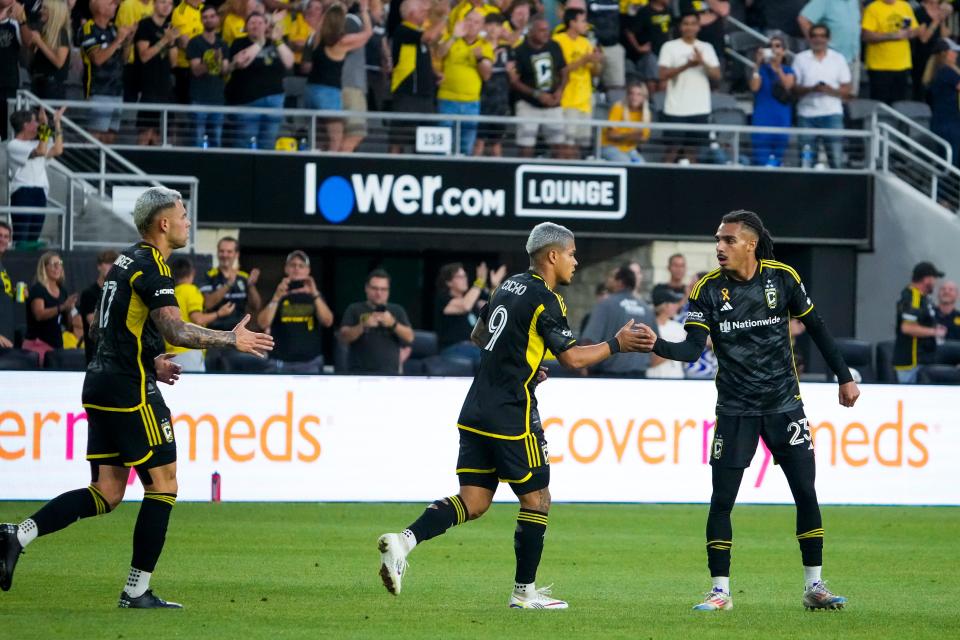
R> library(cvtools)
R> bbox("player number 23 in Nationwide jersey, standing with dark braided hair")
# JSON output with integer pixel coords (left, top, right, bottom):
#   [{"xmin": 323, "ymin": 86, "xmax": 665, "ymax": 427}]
[{"xmin": 653, "ymin": 211, "xmax": 860, "ymax": 611}]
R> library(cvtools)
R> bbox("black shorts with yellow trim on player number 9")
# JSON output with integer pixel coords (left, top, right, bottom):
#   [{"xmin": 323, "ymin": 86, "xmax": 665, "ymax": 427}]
[{"xmin": 457, "ymin": 429, "xmax": 550, "ymax": 496}]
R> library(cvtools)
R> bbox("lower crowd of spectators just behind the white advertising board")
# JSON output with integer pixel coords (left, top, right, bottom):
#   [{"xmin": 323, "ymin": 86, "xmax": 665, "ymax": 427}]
[{"xmin": 0, "ymin": 236, "xmax": 960, "ymax": 384}]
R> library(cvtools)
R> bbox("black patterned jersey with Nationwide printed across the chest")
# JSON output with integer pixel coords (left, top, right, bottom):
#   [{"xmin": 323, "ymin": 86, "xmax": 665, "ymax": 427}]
[{"xmin": 684, "ymin": 260, "xmax": 813, "ymax": 416}]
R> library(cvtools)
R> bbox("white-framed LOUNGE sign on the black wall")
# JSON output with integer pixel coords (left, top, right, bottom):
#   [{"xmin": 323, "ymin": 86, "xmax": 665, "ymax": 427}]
[{"xmin": 515, "ymin": 164, "xmax": 627, "ymax": 220}]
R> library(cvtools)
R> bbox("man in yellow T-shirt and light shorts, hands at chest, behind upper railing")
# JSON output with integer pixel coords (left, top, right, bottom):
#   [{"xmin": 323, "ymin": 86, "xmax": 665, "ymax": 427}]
[{"xmin": 553, "ymin": 9, "xmax": 603, "ymax": 160}]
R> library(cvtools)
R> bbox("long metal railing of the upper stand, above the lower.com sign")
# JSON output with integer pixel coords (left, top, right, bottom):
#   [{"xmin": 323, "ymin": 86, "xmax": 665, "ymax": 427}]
[{"xmin": 22, "ymin": 101, "xmax": 873, "ymax": 171}]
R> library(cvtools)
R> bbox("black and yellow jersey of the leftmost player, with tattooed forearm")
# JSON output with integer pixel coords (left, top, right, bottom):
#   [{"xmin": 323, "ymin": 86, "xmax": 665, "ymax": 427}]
[{"xmin": 83, "ymin": 242, "xmax": 177, "ymax": 411}]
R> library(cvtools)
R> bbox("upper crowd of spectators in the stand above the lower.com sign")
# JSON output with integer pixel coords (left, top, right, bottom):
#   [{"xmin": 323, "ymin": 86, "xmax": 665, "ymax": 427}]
[{"xmin": 0, "ymin": 0, "xmax": 960, "ymax": 167}]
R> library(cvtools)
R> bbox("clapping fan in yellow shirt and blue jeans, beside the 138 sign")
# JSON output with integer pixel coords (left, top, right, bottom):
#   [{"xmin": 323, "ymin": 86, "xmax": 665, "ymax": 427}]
[{"xmin": 437, "ymin": 11, "xmax": 493, "ymax": 156}]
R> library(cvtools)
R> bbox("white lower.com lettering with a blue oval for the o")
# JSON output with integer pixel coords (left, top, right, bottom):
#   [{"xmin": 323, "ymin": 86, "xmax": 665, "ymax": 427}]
[{"xmin": 303, "ymin": 162, "xmax": 507, "ymax": 224}]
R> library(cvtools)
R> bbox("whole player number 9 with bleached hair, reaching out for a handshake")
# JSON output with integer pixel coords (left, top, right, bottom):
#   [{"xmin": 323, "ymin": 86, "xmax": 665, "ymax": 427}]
[{"xmin": 378, "ymin": 222, "xmax": 643, "ymax": 609}]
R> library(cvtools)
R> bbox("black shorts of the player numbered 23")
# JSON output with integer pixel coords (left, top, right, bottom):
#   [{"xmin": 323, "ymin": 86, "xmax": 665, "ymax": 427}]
[{"xmin": 710, "ymin": 409, "xmax": 813, "ymax": 469}]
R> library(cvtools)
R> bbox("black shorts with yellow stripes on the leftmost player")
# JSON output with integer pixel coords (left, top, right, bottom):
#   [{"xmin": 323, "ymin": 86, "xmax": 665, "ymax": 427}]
[{"xmin": 87, "ymin": 382, "xmax": 177, "ymax": 469}]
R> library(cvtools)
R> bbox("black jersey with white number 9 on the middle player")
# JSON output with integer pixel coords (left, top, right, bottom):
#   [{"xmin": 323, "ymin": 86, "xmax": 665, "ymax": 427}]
[{"xmin": 457, "ymin": 271, "xmax": 577, "ymax": 440}]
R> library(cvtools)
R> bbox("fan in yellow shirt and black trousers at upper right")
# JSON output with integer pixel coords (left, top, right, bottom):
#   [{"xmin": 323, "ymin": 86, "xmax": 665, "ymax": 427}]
[{"xmin": 860, "ymin": 0, "xmax": 920, "ymax": 104}]
